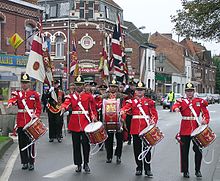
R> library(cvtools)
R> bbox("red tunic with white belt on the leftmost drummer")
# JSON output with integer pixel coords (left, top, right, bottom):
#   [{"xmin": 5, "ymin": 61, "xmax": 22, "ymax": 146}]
[{"xmin": 8, "ymin": 89, "xmax": 41, "ymax": 127}]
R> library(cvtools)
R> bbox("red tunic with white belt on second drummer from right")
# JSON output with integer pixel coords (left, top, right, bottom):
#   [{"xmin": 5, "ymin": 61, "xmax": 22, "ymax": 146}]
[{"xmin": 121, "ymin": 97, "xmax": 158, "ymax": 134}]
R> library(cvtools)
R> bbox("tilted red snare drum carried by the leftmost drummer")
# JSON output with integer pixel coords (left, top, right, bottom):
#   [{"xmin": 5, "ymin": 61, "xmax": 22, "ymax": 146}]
[{"xmin": 23, "ymin": 118, "xmax": 47, "ymax": 142}]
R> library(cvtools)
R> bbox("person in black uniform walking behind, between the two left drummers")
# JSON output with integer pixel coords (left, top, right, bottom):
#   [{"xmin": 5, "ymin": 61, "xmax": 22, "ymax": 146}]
[{"xmin": 47, "ymin": 80, "xmax": 64, "ymax": 143}]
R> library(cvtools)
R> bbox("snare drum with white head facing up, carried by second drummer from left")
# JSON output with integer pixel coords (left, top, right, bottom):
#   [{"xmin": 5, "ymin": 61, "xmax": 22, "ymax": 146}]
[{"xmin": 84, "ymin": 121, "xmax": 108, "ymax": 144}]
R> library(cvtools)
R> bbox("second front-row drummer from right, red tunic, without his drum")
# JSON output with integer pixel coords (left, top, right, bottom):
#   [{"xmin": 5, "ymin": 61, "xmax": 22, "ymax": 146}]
[{"xmin": 121, "ymin": 81, "xmax": 158, "ymax": 177}]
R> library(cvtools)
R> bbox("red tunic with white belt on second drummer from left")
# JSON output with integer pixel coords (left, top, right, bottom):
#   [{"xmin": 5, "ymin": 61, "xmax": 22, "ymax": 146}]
[{"xmin": 61, "ymin": 92, "xmax": 97, "ymax": 132}]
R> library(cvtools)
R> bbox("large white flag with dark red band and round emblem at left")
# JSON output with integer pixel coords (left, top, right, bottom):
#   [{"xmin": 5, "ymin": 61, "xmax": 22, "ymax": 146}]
[{"xmin": 26, "ymin": 32, "xmax": 46, "ymax": 82}]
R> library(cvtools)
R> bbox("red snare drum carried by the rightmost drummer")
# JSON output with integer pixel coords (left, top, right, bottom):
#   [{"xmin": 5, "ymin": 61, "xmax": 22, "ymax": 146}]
[{"xmin": 191, "ymin": 125, "xmax": 216, "ymax": 148}]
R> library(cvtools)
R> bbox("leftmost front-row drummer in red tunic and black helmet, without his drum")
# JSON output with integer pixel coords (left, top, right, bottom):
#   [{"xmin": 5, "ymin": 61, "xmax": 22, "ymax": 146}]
[{"xmin": 8, "ymin": 73, "xmax": 41, "ymax": 170}]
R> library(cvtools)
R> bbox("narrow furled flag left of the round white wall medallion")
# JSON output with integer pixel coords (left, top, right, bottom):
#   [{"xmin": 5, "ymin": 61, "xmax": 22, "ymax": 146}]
[{"xmin": 70, "ymin": 33, "xmax": 79, "ymax": 76}]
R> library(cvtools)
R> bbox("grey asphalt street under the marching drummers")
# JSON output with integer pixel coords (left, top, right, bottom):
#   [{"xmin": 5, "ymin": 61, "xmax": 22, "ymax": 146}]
[{"xmin": 0, "ymin": 104, "xmax": 220, "ymax": 181}]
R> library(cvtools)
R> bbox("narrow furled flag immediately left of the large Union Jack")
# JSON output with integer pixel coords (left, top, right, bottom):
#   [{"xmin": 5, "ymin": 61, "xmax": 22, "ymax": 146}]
[{"xmin": 99, "ymin": 38, "xmax": 109, "ymax": 80}]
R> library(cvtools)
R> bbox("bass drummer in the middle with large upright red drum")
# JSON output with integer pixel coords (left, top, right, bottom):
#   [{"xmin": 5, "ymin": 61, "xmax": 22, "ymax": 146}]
[{"xmin": 102, "ymin": 79, "xmax": 124, "ymax": 164}]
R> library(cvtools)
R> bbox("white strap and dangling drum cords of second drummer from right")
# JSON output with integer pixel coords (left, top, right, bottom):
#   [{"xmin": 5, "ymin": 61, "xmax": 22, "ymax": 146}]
[{"xmin": 134, "ymin": 99, "xmax": 155, "ymax": 164}]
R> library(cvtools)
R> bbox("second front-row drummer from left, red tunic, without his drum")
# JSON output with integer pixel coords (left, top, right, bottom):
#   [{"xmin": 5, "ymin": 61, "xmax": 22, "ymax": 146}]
[{"xmin": 61, "ymin": 76, "xmax": 97, "ymax": 173}]
